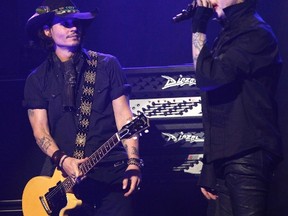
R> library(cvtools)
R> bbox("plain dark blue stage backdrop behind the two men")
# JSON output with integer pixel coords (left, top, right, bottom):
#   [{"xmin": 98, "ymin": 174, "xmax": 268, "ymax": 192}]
[{"xmin": 0, "ymin": 0, "xmax": 288, "ymax": 216}]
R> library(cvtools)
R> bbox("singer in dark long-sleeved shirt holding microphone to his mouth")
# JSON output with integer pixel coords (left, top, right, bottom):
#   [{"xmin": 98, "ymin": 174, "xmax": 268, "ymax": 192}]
[{"xmin": 192, "ymin": 0, "xmax": 282, "ymax": 216}]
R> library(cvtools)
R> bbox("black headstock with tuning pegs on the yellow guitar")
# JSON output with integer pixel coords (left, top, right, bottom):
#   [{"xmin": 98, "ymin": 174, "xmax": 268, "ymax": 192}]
[{"xmin": 118, "ymin": 113, "xmax": 150, "ymax": 139}]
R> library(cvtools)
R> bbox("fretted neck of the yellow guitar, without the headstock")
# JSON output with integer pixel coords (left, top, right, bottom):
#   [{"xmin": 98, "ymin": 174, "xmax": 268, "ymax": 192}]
[{"xmin": 62, "ymin": 133, "xmax": 121, "ymax": 192}]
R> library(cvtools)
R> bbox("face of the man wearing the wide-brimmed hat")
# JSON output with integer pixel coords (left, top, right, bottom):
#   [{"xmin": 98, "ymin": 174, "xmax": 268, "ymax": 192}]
[{"xmin": 44, "ymin": 17, "xmax": 82, "ymax": 49}]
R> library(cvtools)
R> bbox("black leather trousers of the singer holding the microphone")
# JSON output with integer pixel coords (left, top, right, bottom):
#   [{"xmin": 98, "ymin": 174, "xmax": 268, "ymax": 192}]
[{"xmin": 210, "ymin": 150, "xmax": 276, "ymax": 216}]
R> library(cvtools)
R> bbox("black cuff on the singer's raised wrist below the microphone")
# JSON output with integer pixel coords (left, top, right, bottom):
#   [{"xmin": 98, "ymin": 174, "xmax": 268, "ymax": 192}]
[{"xmin": 192, "ymin": 6, "xmax": 213, "ymax": 33}]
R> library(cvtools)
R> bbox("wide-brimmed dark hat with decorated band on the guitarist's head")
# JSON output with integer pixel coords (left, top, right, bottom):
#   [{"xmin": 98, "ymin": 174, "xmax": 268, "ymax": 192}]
[{"xmin": 26, "ymin": 0, "xmax": 97, "ymax": 40}]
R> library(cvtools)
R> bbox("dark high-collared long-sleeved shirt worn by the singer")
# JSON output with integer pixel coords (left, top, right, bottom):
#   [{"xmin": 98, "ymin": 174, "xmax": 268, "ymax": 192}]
[{"xmin": 196, "ymin": 1, "xmax": 281, "ymax": 162}]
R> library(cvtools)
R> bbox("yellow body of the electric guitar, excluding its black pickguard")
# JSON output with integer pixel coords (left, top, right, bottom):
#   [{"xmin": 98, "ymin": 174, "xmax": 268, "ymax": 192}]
[{"xmin": 22, "ymin": 169, "xmax": 82, "ymax": 216}]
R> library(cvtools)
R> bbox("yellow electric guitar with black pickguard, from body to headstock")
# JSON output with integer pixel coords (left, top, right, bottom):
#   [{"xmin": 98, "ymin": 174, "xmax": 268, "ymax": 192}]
[{"xmin": 22, "ymin": 113, "xmax": 149, "ymax": 216}]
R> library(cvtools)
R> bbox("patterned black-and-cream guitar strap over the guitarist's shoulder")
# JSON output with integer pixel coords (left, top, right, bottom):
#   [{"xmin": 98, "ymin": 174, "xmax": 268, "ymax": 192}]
[{"xmin": 73, "ymin": 51, "xmax": 98, "ymax": 159}]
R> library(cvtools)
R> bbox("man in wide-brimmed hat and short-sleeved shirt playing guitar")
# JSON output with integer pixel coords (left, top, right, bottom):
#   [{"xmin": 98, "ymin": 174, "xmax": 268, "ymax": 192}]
[{"xmin": 24, "ymin": 0, "xmax": 143, "ymax": 216}]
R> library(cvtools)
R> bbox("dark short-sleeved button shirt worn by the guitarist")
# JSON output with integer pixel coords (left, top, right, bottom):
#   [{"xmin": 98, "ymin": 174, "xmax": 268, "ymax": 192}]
[{"xmin": 24, "ymin": 49, "xmax": 130, "ymax": 176}]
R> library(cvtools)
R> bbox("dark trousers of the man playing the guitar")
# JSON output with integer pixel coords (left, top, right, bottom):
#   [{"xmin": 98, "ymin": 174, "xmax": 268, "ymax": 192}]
[{"xmin": 69, "ymin": 160, "xmax": 135, "ymax": 216}]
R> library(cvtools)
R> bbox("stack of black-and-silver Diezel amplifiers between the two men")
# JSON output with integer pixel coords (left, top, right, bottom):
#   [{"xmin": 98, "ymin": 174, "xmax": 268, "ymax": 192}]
[{"xmin": 124, "ymin": 64, "xmax": 204, "ymax": 180}]
